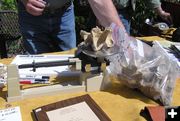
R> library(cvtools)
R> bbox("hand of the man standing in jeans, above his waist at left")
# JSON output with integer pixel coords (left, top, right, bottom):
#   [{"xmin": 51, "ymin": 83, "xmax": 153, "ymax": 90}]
[{"xmin": 21, "ymin": 0, "xmax": 46, "ymax": 16}]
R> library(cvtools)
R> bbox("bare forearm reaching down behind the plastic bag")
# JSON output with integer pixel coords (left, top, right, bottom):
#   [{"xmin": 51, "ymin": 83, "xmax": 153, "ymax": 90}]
[{"xmin": 88, "ymin": 0, "xmax": 124, "ymax": 29}]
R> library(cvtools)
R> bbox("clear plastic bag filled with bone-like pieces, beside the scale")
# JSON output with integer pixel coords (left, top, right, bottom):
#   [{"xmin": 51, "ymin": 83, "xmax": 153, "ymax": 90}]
[{"xmin": 107, "ymin": 24, "xmax": 180, "ymax": 105}]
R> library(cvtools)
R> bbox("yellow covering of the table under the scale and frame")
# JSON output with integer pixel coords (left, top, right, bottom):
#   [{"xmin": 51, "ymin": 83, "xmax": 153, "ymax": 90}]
[{"xmin": 0, "ymin": 37, "xmax": 180, "ymax": 121}]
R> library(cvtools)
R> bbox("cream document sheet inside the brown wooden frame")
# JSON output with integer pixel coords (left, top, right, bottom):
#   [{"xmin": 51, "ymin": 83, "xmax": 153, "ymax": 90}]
[{"xmin": 46, "ymin": 102, "xmax": 100, "ymax": 121}]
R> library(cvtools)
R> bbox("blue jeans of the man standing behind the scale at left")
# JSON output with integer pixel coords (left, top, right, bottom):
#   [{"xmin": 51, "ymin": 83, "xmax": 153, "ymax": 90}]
[{"xmin": 18, "ymin": 2, "xmax": 76, "ymax": 54}]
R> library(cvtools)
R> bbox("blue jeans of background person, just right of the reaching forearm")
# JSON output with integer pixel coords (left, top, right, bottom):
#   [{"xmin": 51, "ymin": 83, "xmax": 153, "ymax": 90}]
[{"xmin": 117, "ymin": 10, "xmax": 131, "ymax": 34}]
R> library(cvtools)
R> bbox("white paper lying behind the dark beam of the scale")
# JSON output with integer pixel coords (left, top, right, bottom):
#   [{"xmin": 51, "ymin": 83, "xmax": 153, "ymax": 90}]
[{"xmin": 11, "ymin": 54, "xmax": 74, "ymax": 77}]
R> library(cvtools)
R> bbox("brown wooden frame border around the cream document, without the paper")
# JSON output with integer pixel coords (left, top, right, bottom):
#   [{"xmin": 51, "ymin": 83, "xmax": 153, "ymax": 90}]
[{"xmin": 33, "ymin": 94, "xmax": 111, "ymax": 121}]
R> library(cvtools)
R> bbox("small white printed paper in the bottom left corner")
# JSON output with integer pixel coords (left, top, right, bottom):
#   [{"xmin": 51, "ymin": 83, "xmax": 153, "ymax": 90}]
[{"xmin": 0, "ymin": 107, "xmax": 22, "ymax": 121}]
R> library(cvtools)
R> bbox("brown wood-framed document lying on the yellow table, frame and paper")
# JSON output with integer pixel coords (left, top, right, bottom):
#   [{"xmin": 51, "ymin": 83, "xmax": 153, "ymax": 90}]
[{"xmin": 33, "ymin": 95, "xmax": 111, "ymax": 121}]
